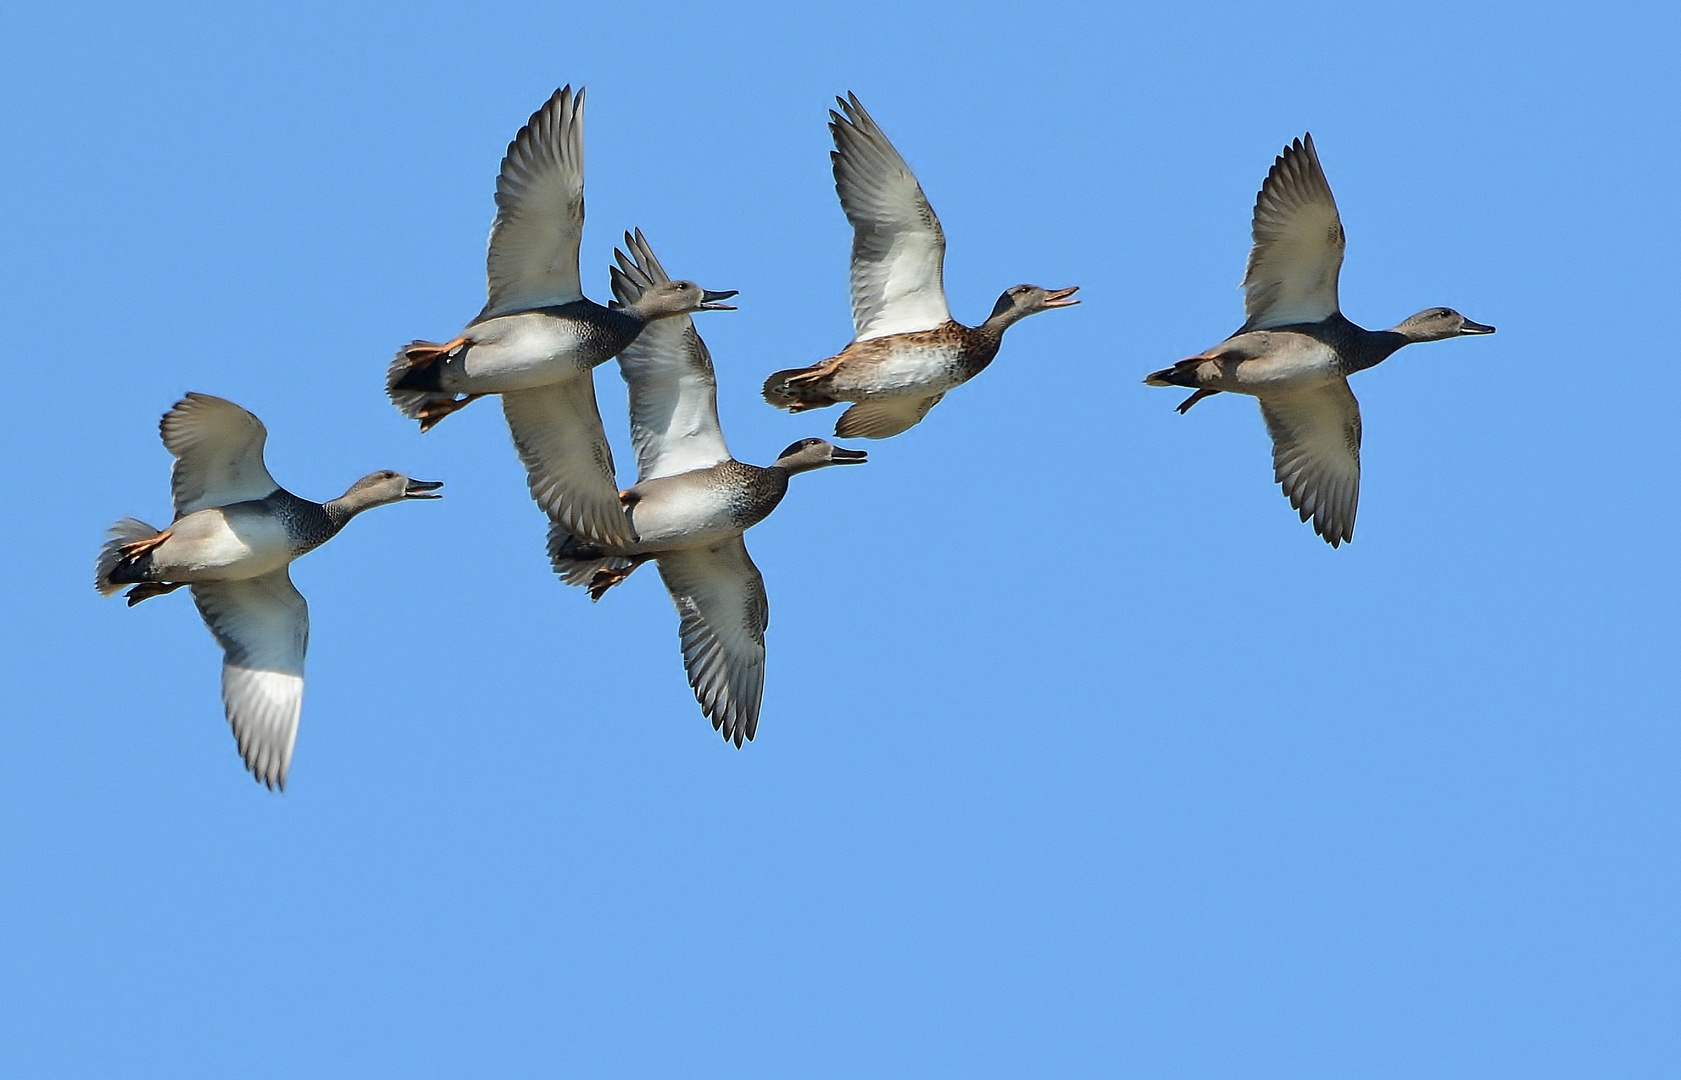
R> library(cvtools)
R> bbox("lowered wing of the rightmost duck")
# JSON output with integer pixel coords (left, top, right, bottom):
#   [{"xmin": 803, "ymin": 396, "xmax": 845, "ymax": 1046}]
[{"xmin": 1261, "ymin": 379, "xmax": 1360, "ymax": 547}]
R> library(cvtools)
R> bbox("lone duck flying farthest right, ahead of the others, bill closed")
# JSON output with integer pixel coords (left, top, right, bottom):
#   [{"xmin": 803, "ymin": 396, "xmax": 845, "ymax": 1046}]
[{"xmin": 1145, "ymin": 135, "xmax": 1494, "ymax": 547}]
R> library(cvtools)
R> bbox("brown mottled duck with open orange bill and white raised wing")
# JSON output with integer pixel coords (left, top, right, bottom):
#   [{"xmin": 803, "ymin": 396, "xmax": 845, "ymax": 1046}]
[{"xmin": 763, "ymin": 94, "xmax": 1079, "ymax": 439}]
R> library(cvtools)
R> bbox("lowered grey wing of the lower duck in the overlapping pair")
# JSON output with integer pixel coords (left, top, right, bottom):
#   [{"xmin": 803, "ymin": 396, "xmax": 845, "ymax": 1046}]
[{"xmin": 659, "ymin": 537, "xmax": 770, "ymax": 747}]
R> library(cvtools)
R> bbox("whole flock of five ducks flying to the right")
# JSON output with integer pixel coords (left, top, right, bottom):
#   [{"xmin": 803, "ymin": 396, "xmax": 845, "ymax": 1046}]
[{"xmin": 96, "ymin": 86, "xmax": 1494, "ymax": 789}]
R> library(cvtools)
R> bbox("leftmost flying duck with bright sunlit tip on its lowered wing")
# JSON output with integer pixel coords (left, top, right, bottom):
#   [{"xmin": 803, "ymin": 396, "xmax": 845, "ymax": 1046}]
[{"xmin": 94, "ymin": 394, "xmax": 444, "ymax": 791}]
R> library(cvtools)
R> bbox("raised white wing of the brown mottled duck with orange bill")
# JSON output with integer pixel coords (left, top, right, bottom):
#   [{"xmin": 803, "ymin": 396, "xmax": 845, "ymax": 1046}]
[{"xmin": 829, "ymin": 94, "xmax": 951, "ymax": 341}]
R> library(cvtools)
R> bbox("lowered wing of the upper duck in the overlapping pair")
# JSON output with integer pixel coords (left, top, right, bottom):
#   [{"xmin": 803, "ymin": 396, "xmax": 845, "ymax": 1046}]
[{"xmin": 501, "ymin": 372, "xmax": 632, "ymax": 547}]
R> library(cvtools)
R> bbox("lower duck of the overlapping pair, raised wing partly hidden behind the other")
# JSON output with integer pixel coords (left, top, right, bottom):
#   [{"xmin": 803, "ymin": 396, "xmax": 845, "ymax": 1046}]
[{"xmin": 548, "ymin": 236, "xmax": 866, "ymax": 747}]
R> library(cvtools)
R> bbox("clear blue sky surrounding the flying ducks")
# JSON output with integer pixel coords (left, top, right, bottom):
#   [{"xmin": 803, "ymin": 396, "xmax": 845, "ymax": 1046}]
[{"xmin": 0, "ymin": 2, "xmax": 1681, "ymax": 1078}]
